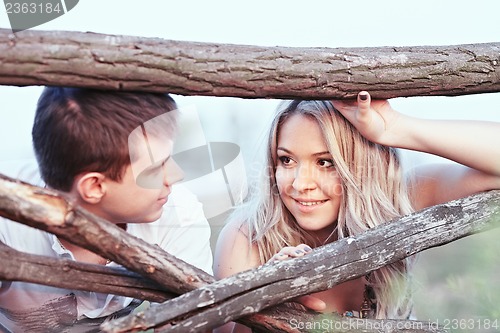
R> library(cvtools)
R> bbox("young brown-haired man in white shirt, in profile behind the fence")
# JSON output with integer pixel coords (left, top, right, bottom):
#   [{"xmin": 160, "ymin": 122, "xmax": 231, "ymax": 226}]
[{"xmin": 0, "ymin": 87, "xmax": 212, "ymax": 332}]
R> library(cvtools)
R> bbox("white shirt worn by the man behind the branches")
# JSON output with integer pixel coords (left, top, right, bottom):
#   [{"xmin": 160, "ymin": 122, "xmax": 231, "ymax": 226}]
[{"xmin": 0, "ymin": 185, "xmax": 212, "ymax": 333}]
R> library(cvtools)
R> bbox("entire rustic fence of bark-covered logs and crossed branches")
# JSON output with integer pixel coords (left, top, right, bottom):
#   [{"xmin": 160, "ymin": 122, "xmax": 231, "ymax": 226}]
[{"xmin": 0, "ymin": 29, "xmax": 500, "ymax": 332}]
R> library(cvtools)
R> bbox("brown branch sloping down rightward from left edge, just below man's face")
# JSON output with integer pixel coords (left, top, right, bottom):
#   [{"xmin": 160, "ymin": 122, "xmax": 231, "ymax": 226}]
[{"xmin": 0, "ymin": 175, "xmax": 214, "ymax": 294}]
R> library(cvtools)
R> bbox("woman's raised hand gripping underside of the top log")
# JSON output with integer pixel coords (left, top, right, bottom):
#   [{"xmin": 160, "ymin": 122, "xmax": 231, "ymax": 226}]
[{"xmin": 332, "ymin": 91, "xmax": 401, "ymax": 145}]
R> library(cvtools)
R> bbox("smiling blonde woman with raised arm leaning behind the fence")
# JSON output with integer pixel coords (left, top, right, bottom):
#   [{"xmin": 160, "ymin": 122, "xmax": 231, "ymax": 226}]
[{"xmin": 214, "ymin": 92, "xmax": 500, "ymax": 332}]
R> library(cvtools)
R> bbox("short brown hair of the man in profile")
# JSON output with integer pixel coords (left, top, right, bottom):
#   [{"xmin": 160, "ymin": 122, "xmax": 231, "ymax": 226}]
[{"xmin": 32, "ymin": 87, "xmax": 177, "ymax": 192}]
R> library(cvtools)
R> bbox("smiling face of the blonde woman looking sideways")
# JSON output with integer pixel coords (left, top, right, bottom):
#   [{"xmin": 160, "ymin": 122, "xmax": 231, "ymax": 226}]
[{"xmin": 276, "ymin": 114, "xmax": 342, "ymax": 241}]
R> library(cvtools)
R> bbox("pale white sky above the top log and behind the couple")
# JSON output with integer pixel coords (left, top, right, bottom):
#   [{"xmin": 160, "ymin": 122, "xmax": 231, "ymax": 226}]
[{"xmin": 0, "ymin": 0, "xmax": 500, "ymax": 319}]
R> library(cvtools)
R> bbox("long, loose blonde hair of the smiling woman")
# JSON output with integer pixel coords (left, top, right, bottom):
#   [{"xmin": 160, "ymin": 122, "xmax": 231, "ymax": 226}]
[{"xmin": 232, "ymin": 100, "xmax": 413, "ymax": 319}]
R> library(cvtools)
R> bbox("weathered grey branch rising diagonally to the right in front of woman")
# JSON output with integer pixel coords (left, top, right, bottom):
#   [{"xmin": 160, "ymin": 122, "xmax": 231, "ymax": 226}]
[{"xmin": 103, "ymin": 191, "xmax": 500, "ymax": 332}]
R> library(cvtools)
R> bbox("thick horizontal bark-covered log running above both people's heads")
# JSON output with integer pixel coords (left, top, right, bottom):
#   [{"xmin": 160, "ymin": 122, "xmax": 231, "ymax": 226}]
[{"xmin": 0, "ymin": 29, "xmax": 500, "ymax": 99}]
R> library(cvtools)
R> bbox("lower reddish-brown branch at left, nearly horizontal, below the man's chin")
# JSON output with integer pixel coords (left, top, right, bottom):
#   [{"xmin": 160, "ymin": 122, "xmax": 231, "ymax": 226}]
[{"xmin": 0, "ymin": 242, "xmax": 176, "ymax": 302}]
